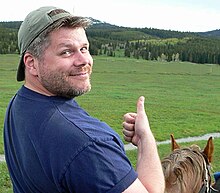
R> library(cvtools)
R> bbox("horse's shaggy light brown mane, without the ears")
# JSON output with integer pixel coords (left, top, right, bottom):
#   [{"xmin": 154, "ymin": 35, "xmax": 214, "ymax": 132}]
[{"xmin": 162, "ymin": 145, "xmax": 207, "ymax": 193}]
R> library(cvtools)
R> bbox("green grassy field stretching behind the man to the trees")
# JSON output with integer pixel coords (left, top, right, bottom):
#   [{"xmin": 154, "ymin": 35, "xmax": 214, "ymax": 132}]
[{"xmin": 0, "ymin": 55, "xmax": 220, "ymax": 192}]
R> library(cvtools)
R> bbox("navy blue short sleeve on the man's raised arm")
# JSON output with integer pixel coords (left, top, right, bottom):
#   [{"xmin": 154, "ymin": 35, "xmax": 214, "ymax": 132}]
[{"xmin": 59, "ymin": 140, "xmax": 137, "ymax": 193}]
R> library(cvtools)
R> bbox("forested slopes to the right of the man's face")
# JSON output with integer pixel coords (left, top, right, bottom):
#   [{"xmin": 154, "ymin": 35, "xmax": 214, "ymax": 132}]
[{"xmin": 88, "ymin": 27, "xmax": 220, "ymax": 64}]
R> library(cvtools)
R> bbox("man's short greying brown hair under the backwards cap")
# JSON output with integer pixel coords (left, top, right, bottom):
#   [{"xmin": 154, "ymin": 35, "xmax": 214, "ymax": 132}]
[{"xmin": 26, "ymin": 9, "xmax": 92, "ymax": 60}]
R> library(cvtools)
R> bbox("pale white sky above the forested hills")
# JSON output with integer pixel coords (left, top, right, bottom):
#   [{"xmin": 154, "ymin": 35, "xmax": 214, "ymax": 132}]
[{"xmin": 0, "ymin": 0, "xmax": 220, "ymax": 32}]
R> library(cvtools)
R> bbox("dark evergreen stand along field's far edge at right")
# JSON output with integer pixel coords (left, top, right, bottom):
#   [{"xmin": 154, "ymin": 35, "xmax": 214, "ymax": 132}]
[{"xmin": 125, "ymin": 37, "xmax": 220, "ymax": 64}]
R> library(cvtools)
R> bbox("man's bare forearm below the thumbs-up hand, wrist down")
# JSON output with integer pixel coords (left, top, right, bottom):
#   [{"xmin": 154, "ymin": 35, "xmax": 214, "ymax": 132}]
[{"xmin": 136, "ymin": 131, "xmax": 165, "ymax": 193}]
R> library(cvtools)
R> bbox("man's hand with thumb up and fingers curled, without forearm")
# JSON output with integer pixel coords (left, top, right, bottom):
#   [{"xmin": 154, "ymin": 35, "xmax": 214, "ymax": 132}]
[{"xmin": 123, "ymin": 96, "xmax": 150, "ymax": 146}]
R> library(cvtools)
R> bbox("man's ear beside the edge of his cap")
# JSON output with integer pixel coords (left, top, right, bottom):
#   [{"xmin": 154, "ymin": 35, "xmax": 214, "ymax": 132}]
[{"xmin": 24, "ymin": 52, "xmax": 38, "ymax": 76}]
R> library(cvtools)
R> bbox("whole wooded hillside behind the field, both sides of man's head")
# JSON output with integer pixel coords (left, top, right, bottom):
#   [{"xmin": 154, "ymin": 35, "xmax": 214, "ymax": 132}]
[{"xmin": 0, "ymin": 18, "xmax": 220, "ymax": 64}]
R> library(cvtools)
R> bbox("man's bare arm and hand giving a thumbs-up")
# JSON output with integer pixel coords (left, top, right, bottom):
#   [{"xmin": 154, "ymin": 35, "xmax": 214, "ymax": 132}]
[{"xmin": 123, "ymin": 97, "xmax": 165, "ymax": 193}]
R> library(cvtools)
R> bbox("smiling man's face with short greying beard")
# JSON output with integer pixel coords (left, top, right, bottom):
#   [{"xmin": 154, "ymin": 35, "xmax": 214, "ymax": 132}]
[{"xmin": 38, "ymin": 28, "xmax": 93, "ymax": 98}]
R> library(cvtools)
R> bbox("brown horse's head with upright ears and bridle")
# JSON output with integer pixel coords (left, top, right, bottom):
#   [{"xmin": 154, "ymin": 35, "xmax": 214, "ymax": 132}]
[{"xmin": 161, "ymin": 135, "xmax": 218, "ymax": 193}]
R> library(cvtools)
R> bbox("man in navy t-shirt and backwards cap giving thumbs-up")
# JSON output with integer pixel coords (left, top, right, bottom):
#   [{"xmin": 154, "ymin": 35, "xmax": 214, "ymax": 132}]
[{"xmin": 4, "ymin": 7, "xmax": 164, "ymax": 193}]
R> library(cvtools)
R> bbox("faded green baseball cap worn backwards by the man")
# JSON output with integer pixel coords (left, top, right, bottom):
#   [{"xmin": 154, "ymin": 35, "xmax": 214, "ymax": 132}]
[{"xmin": 17, "ymin": 6, "xmax": 73, "ymax": 81}]
